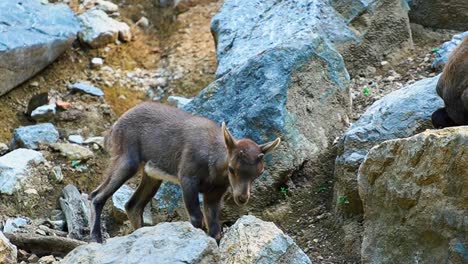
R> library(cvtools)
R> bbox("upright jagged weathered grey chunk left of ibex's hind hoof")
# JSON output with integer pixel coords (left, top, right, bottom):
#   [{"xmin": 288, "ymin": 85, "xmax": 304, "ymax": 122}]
[{"xmin": 60, "ymin": 184, "xmax": 91, "ymax": 239}]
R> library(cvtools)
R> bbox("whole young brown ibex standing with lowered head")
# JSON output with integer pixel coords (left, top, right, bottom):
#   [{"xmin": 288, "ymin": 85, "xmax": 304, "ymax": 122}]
[{"xmin": 90, "ymin": 103, "xmax": 281, "ymax": 243}]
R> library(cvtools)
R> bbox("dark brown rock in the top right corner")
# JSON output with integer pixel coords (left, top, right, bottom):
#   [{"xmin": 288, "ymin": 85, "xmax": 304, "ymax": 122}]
[{"xmin": 409, "ymin": 0, "xmax": 468, "ymax": 30}]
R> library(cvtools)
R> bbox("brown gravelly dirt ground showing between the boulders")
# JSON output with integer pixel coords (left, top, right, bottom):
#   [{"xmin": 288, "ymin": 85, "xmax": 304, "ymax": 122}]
[{"xmin": 0, "ymin": 0, "xmax": 464, "ymax": 263}]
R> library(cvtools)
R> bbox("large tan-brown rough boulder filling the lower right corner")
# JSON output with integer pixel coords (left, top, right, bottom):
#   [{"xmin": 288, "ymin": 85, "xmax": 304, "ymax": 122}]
[{"xmin": 358, "ymin": 126, "xmax": 468, "ymax": 264}]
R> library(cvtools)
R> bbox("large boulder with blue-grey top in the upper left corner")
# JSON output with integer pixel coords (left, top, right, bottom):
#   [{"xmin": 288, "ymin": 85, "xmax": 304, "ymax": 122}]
[{"xmin": 0, "ymin": 0, "xmax": 80, "ymax": 95}]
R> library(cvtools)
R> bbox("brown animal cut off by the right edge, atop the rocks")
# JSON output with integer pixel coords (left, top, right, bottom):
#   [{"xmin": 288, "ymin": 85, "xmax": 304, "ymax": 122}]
[{"xmin": 432, "ymin": 37, "xmax": 468, "ymax": 128}]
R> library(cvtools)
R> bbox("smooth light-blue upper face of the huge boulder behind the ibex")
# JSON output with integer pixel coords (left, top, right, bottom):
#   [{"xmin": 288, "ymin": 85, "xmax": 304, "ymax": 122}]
[{"xmin": 211, "ymin": 0, "xmax": 357, "ymax": 77}]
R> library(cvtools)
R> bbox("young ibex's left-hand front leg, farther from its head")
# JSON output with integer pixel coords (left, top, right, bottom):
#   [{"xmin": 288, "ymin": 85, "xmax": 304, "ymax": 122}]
[{"xmin": 180, "ymin": 176, "xmax": 203, "ymax": 228}]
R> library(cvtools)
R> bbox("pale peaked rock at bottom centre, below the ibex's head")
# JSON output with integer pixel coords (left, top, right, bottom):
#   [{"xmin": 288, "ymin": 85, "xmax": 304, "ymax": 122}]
[{"xmin": 219, "ymin": 215, "xmax": 312, "ymax": 264}]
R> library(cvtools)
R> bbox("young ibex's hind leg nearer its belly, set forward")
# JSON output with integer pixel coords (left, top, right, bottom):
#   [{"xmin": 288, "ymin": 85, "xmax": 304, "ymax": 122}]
[{"xmin": 125, "ymin": 173, "xmax": 162, "ymax": 229}]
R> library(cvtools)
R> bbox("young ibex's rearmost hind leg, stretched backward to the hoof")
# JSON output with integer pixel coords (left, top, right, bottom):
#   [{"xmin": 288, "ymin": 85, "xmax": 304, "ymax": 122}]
[{"xmin": 91, "ymin": 155, "xmax": 139, "ymax": 243}]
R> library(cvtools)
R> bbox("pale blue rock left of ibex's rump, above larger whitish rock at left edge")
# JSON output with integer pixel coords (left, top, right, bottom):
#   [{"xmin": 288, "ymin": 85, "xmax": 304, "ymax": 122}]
[{"xmin": 10, "ymin": 123, "xmax": 59, "ymax": 149}]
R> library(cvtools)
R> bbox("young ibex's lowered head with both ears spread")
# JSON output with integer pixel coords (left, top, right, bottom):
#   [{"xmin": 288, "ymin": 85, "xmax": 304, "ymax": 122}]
[{"xmin": 222, "ymin": 122, "xmax": 281, "ymax": 205}]
